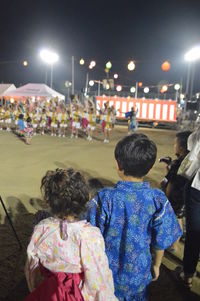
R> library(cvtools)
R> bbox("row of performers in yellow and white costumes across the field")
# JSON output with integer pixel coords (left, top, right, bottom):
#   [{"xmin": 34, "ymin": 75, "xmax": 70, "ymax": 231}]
[{"xmin": 0, "ymin": 98, "xmax": 120, "ymax": 144}]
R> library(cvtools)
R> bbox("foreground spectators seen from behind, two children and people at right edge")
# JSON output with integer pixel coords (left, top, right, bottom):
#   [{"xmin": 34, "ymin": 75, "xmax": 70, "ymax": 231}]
[{"xmin": 20, "ymin": 129, "xmax": 200, "ymax": 301}]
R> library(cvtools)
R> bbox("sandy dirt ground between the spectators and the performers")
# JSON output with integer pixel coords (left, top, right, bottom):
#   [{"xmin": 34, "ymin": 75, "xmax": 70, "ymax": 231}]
[{"xmin": 0, "ymin": 126, "xmax": 200, "ymax": 301}]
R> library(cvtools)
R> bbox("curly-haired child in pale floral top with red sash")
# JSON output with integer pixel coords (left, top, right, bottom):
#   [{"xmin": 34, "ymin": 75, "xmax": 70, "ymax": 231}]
[{"xmin": 25, "ymin": 169, "xmax": 117, "ymax": 301}]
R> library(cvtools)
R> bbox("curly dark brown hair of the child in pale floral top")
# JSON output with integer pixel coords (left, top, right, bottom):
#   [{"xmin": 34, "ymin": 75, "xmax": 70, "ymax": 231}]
[{"xmin": 40, "ymin": 168, "xmax": 89, "ymax": 218}]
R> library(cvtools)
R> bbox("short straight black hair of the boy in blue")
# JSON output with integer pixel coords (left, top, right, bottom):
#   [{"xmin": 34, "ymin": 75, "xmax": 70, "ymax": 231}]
[{"xmin": 115, "ymin": 133, "xmax": 157, "ymax": 178}]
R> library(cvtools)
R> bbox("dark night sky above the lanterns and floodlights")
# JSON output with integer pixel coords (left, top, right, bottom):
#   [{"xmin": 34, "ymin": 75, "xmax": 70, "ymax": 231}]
[{"xmin": 0, "ymin": 0, "xmax": 200, "ymax": 92}]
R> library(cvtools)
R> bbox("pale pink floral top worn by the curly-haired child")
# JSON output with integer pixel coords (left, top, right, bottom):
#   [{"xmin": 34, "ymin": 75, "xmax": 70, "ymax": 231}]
[{"xmin": 25, "ymin": 217, "xmax": 118, "ymax": 301}]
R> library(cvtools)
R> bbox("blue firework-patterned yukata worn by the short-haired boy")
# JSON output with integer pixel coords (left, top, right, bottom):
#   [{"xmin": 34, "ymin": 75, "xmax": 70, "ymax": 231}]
[{"xmin": 88, "ymin": 181, "xmax": 182, "ymax": 301}]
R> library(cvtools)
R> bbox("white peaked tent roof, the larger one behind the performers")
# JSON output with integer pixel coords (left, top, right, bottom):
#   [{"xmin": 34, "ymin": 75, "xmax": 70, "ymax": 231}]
[{"xmin": 4, "ymin": 84, "xmax": 65, "ymax": 100}]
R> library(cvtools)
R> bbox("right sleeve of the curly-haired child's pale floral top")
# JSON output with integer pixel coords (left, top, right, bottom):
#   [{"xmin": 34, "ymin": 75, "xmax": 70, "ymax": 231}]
[{"xmin": 81, "ymin": 226, "xmax": 117, "ymax": 301}]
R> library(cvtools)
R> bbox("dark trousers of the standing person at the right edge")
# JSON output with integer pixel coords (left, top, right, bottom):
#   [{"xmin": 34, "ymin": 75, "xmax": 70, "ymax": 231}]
[{"xmin": 183, "ymin": 187, "xmax": 200, "ymax": 277}]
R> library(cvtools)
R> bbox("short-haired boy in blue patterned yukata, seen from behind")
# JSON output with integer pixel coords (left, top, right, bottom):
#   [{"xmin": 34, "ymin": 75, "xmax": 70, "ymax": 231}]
[{"xmin": 88, "ymin": 133, "xmax": 182, "ymax": 301}]
